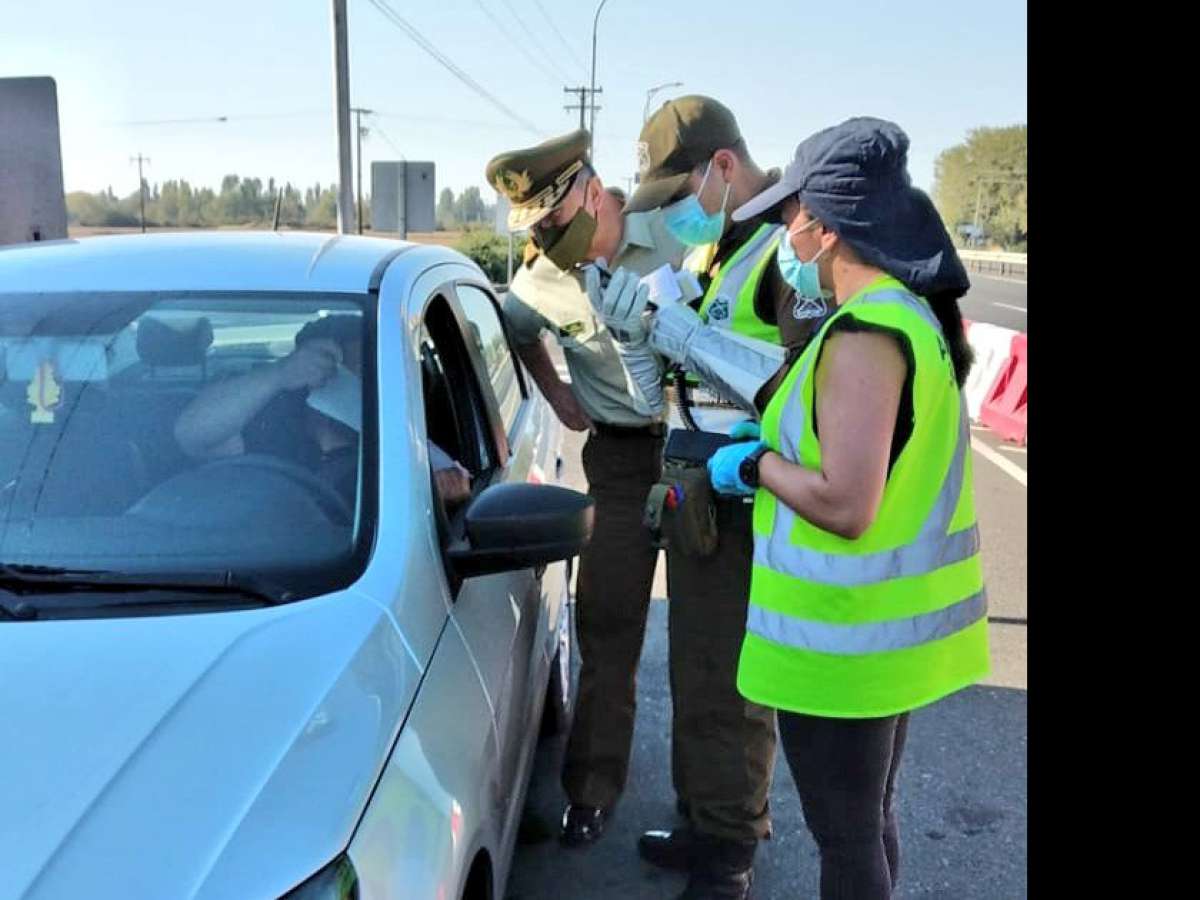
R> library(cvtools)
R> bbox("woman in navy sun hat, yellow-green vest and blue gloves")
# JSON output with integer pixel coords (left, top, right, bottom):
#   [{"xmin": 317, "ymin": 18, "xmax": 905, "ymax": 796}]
[{"xmin": 709, "ymin": 119, "xmax": 989, "ymax": 900}]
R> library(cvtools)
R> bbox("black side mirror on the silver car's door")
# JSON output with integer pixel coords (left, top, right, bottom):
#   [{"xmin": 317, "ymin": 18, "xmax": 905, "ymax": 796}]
[{"xmin": 448, "ymin": 484, "xmax": 595, "ymax": 578}]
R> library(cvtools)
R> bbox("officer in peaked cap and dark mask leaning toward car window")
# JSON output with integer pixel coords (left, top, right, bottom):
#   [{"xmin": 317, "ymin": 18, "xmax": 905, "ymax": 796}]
[{"xmin": 486, "ymin": 130, "xmax": 684, "ymax": 846}]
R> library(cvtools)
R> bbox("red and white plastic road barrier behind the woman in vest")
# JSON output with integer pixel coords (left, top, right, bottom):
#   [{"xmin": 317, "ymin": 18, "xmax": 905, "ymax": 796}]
[{"xmin": 962, "ymin": 322, "xmax": 1028, "ymax": 444}]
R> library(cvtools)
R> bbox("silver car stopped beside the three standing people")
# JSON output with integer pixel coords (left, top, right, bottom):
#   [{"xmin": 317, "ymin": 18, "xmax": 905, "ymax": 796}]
[{"xmin": 0, "ymin": 233, "xmax": 593, "ymax": 900}]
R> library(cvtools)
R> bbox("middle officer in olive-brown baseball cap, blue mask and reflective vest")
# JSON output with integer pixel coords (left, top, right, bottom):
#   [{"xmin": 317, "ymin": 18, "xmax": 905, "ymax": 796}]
[{"xmin": 625, "ymin": 96, "xmax": 827, "ymax": 900}]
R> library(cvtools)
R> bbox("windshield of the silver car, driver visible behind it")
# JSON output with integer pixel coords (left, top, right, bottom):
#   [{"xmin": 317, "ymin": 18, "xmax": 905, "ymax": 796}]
[{"xmin": 0, "ymin": 293, "xmax": 374, "ymax": 607}]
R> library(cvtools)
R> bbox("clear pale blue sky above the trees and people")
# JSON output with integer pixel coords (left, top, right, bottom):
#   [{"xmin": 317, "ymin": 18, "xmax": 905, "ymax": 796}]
[{"xmin": 0, "ymin": 0, "xmax": 1027, "ymax": 202}]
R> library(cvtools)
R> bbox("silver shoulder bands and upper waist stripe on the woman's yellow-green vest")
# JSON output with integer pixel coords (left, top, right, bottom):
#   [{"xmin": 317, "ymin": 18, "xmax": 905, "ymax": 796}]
[{"xmin": 768, "ymin": 290, "xmax": 979, "ymax": 587}]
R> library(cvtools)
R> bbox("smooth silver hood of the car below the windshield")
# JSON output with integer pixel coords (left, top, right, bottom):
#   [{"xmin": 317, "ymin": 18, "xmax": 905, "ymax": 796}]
[{"xmin": 0, "ymin": 592, "xmax": 420, "ymax": 898}]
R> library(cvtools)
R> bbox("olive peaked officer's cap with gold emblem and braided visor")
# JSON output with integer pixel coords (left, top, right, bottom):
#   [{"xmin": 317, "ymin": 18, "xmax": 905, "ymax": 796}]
[{"xmin": 484, "ymin": 128, "xmax": 588, "ymax": 230}]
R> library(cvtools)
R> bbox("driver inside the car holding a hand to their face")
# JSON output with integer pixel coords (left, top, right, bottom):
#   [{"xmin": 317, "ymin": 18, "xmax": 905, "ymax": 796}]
[{"xmin": 175, "ymin": 314, "xmax": 470, "ymax": 506}]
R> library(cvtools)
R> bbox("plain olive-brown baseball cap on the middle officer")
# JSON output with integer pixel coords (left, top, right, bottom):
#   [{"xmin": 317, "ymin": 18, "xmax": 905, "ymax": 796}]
[{"xmin": 625, "ymin": 94, "xmax": 742, "ymax": 212}]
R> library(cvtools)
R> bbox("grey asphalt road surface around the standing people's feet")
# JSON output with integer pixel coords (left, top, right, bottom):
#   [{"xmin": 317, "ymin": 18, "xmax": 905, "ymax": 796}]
[{"xmin": 506, "ymin": 417, "xmax": 1027, "ymax": 900}]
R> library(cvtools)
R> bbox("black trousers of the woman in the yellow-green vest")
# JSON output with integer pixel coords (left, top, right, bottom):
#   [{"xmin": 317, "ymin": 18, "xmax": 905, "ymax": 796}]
[{"xmin": 779, "ymin": 709, "xmax": 908, "ymax": 900}]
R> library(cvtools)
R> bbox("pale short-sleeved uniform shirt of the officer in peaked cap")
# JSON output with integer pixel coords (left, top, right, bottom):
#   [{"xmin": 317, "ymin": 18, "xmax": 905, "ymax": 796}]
[{"xmin": 504, "ymin": 210, "xmax": 686, "ymax": 426}]
